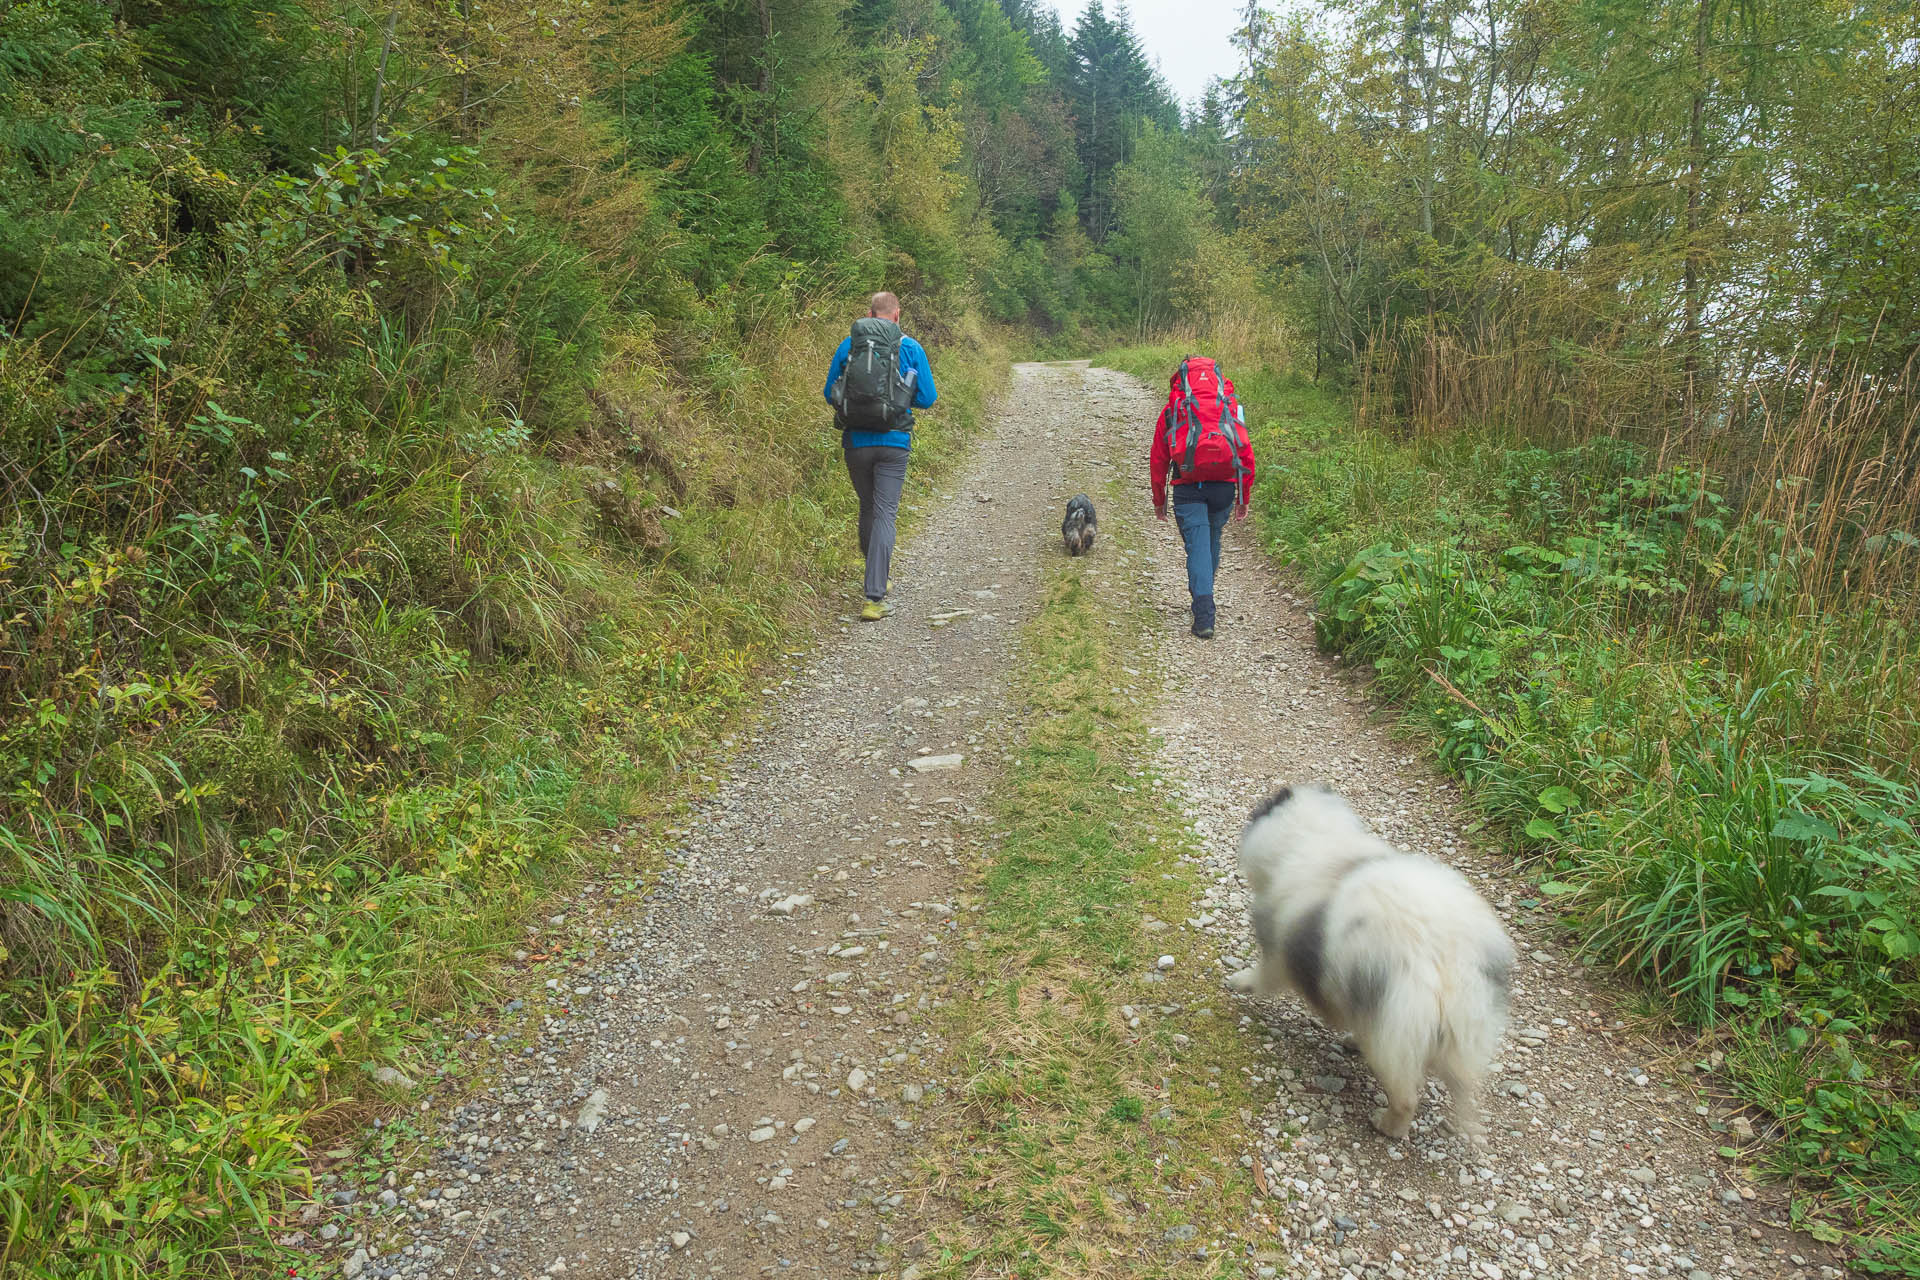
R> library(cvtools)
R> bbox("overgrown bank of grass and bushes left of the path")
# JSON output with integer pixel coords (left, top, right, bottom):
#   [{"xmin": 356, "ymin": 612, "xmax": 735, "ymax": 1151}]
[{"xmin": 0, "ymin": 0, "xmax": 1004, "ymax": 1278}]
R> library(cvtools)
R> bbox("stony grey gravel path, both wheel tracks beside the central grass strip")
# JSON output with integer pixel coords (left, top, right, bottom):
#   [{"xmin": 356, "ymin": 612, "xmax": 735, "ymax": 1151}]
[{"xmin": 300, "ymin": 365, "xmax": 1837, "ymax": 1280}]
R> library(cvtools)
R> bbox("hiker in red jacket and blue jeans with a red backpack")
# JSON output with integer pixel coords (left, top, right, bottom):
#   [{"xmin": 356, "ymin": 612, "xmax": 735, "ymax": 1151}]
[{"xmin": 1148, "ymin": 355, "xmax": 1254, "ymax": 639}]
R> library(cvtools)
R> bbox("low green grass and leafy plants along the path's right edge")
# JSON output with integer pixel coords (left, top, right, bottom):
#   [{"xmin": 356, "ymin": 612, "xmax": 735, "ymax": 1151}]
[{"xmin": 1108, "ymin": 349, "xmax": 1920, "ymax": 1270}]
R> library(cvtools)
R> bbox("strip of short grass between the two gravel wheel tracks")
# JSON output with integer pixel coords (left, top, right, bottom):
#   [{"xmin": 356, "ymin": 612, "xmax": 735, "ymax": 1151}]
[{"xmin": 906, "ymin": 479, "xmax": 1265, "ymax": 1280}]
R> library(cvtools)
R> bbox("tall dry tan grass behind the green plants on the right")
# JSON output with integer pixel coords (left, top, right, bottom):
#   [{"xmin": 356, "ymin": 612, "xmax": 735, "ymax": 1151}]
[{"xmin": 1354, "ymin": 328, "xmax": 1920, "ymax": 677}]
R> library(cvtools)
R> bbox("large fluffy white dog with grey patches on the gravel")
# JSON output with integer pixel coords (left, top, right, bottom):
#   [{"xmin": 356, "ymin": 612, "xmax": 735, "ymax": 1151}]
[{"xmin": 1229, "ymin": 787, "xmax": 1513, "ymax": 1144}]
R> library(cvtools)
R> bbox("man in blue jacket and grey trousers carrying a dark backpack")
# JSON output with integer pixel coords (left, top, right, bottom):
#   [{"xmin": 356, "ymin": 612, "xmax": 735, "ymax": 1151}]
[{"xmin": 826, "ymin": 294, "xmax": 937, "ymax": 622}]
